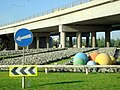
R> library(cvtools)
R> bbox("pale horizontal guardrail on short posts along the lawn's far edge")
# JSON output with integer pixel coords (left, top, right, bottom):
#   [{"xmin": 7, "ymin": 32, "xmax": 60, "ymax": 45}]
[{"xmin": 0, "ymin": 65, "xmax": 120, "ymax": 74}]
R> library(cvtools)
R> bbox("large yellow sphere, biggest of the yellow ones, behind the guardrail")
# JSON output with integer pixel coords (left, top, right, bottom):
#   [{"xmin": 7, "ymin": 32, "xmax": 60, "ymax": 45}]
[{"xmin": 95, "ymin": 53, "xmax": 111, "ymax": 65}]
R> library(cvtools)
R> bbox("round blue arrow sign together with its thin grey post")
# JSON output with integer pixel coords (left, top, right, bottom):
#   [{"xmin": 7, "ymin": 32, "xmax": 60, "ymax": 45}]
[{"xmin": 14, "ymin": 28, "xmax": 33, "ymax": 89}]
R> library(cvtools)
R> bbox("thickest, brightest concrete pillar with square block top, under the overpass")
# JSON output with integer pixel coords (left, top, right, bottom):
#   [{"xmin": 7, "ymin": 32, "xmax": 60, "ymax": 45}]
[{"xmin": 59, "ymin": 25, "xmax": 66, "ymax": 48}]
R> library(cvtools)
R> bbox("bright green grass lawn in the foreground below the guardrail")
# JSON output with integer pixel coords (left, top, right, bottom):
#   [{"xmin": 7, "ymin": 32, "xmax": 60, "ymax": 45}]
[{"xmin": 0, "ymin": 72, "xmax": 120, "ymax": 90}]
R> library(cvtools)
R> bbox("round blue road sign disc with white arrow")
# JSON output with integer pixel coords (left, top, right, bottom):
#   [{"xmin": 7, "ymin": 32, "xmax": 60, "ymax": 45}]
[{"xmin": 14, "ymin": 28, "xmax": 33, "ymax": 47}]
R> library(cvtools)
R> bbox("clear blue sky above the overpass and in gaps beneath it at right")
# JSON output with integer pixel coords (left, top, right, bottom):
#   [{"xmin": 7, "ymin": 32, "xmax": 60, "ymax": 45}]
[{"xmin": 0, "ymin": 0, "xmax": 120, "ymax": 39}]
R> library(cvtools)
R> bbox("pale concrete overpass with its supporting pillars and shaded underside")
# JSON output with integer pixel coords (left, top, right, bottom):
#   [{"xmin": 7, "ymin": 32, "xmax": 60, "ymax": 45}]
[{"xmin": 0, "ymin": 0, "xmax": 120, "ymax": 50}]
